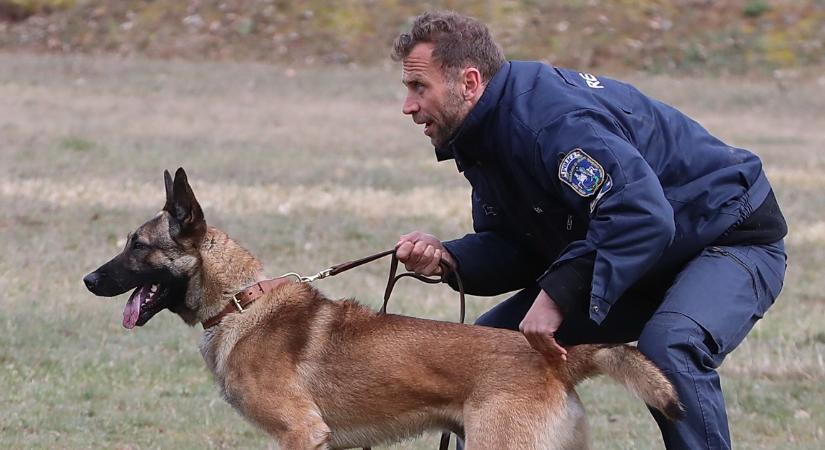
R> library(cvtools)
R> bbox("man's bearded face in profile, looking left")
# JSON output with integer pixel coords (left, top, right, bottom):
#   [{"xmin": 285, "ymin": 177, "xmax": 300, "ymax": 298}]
[{"xmin": 401, "ymin": 42, "xmax": 471, "ymax": 147}]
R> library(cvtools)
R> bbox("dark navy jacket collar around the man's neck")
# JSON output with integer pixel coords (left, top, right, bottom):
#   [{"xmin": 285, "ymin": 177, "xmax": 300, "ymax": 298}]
[{"xmin": 435, "ymin": 61, "xmax": 510, "ymax": 172}]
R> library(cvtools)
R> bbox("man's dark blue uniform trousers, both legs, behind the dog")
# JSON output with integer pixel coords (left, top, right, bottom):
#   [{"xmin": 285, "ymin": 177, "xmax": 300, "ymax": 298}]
[{"xmin": 466, "ymin": 241, "xmax": 786, "ymax": 450}]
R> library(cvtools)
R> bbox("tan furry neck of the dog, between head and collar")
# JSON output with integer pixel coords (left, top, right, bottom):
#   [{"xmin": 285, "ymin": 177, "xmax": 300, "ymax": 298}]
[{"xmin": 186, "ymin": 227, "xmax": 264, "ymax": 322}]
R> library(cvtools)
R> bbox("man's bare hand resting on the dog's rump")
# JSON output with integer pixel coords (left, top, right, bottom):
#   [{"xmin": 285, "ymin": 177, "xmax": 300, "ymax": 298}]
[{"xmin": 519, "ymin": 289, "xmax": 567, "ymax": 361}]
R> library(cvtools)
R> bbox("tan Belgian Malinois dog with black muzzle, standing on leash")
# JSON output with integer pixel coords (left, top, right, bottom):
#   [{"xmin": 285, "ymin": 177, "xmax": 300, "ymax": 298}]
[{"xmin": 84, "ymin": 169, "xmax": 681, "ymax": 450}]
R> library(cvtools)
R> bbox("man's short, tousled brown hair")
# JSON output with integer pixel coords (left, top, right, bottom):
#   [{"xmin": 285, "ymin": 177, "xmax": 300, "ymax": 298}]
[{"xmin": 392, "ymin": 11, "xmax": 504, "ymax": 83}]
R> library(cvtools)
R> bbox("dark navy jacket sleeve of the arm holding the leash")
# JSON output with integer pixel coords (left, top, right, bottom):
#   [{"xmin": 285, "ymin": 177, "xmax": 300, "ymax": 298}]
[{"xmin": 444, "ymin": 193, "xmax": 546, "ymax": 296}]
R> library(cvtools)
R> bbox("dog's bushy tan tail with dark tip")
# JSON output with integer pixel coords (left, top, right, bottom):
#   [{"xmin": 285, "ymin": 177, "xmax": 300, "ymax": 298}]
[{"xmin": 564, "ymin": 345, "xmax": 684, "ymax": 420}]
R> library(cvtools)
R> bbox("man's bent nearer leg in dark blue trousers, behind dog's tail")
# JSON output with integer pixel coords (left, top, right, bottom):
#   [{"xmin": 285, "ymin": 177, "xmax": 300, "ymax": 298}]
[{"xmin": 639, "ymin": 242, "xmax": 785, "ymax": 449}]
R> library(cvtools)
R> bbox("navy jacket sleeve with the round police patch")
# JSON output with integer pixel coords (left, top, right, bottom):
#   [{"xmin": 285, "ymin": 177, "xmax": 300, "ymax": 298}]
[{"xmin": 535, "ymin": 111, "xmax": 675, "ymax": 323}]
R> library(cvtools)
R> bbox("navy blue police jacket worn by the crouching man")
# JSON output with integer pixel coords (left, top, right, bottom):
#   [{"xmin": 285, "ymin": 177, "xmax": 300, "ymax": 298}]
[{"xmin": 436, "ymin": 62, "xmax": 771, "ymax": 323}]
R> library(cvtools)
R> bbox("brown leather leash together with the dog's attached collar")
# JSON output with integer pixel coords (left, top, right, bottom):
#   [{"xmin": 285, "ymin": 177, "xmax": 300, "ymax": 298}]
[{"xmin": 201, "ymin": 248, "xmax": 466, "ymax": 450}]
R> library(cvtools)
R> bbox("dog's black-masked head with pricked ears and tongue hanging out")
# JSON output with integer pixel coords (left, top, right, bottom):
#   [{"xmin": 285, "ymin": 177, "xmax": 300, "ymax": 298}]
[{"xmin": 83, "ymin": 168, "xmax": 206, "ymax": 328}]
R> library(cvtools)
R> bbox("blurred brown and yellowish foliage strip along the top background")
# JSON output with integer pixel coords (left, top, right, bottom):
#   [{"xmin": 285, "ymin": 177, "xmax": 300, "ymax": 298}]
[{"xmin": 0, "ymin": 0, "xmax": 825, "ymax": 73}]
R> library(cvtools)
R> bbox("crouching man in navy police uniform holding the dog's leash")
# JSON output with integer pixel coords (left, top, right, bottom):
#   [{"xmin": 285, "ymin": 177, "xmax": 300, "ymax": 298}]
[{"xmin": 393, "ymin": 12, "xmax": 787, "ymax": 449}]
